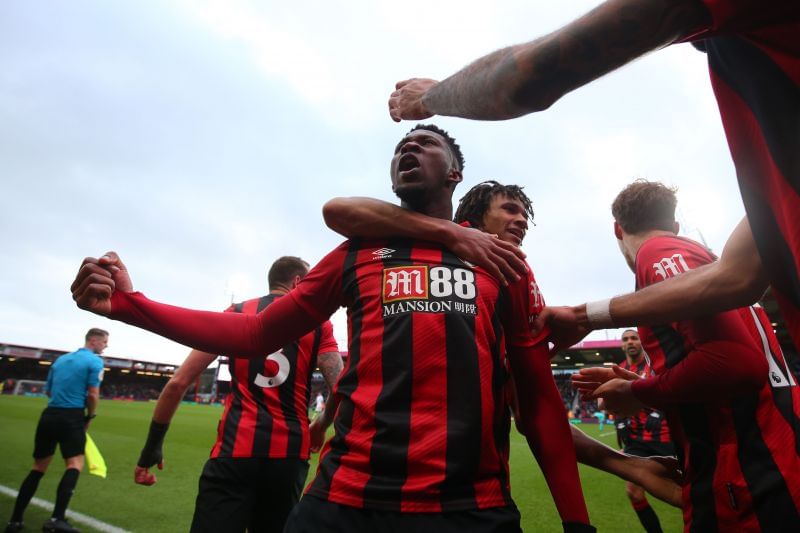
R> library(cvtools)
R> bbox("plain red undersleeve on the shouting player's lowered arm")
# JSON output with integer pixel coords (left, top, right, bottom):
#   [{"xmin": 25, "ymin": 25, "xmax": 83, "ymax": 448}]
[{"xmin": 508, "ymin": 343, "xmax": 589, "ymax": 524}]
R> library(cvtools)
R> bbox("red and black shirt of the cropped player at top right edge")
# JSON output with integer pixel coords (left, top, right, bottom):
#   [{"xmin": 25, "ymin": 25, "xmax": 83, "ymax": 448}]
[{"xmin": 688, "ymin": 0, "xmax": 800, "ymax": 349}]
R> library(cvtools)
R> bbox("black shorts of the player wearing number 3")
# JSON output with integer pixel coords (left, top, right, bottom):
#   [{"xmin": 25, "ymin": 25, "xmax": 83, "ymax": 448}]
[{"xmin": 191, "ymin": 457, "xmax": 308, "ymax": 533}]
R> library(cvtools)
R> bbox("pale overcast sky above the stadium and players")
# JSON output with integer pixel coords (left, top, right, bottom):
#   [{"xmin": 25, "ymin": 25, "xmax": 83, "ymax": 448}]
[{"xmin": 0, "ymin": 0, "xmax": 743, "ymax": 362}]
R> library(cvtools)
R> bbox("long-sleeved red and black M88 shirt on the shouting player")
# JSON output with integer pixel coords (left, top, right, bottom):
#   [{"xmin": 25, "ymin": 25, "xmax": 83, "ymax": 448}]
[{"xmin": 110, "ymin": 239, "xmax": 588, "ymax": 522}]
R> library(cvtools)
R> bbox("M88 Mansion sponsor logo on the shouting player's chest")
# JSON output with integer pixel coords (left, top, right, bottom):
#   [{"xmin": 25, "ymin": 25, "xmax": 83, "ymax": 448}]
[{"xmin": 382, "ymin": 265, "xmax": 477, "ymax": 316}]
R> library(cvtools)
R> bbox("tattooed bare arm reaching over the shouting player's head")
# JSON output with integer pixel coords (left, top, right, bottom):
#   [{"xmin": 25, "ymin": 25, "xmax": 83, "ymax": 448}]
[{"xmin": 389, "ymin": 0, "xmax": 710, "ymax": 122}]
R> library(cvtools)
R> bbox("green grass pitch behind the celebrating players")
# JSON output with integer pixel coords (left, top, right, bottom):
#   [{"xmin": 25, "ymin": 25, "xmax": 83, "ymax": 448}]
[{"xmin": 0, "ymin": 395, "xmax": 682, "ymax": 533}]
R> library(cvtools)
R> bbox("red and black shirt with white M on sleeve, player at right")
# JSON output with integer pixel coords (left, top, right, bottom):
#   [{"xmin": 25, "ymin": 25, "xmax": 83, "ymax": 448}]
[{"xmin": 634, "ymin": 237, "xmax": 800, "ymax": 532}]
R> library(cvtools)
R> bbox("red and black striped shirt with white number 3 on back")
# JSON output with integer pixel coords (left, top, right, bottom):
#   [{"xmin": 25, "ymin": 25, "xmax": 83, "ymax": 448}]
[{"xmin": 211, "ymin": 294, "xmax": 339, "ymax": 459}]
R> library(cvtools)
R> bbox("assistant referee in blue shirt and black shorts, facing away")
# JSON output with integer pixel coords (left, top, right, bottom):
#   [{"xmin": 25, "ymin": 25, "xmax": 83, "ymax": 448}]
[{"xmin": 6, "ymin": 328, "xmax": 108, "ymax": 533}]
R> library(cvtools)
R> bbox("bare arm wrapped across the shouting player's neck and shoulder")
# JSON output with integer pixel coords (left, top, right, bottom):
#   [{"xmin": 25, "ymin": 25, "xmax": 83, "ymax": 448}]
[{"xmin": 322, "ymin": 197, "xmax": 527, "ymax": 284}]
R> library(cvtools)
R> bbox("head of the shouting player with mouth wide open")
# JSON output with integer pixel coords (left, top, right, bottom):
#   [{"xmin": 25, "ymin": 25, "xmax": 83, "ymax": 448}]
[{"xmin": 391, "ymin": 130, "xmax": 453, "ymax": 205}]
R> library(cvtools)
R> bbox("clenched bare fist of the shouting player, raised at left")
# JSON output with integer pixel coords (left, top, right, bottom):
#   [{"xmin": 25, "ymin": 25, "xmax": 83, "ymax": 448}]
[{"xmin": 70, "ymin": 252, "xmax": 133, "ymax": 316}]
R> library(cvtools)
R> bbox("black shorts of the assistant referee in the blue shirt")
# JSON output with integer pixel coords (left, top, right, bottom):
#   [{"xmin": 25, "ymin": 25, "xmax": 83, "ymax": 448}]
[{"xmin": 33, "ymin": 407, "xmax": 86, "ymax": 459}]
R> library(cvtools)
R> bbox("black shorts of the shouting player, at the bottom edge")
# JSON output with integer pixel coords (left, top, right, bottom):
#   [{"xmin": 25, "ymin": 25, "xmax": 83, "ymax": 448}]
[{"xmin": 284, "ymin": 496, "xmax": 522, "ymax": 533}]
